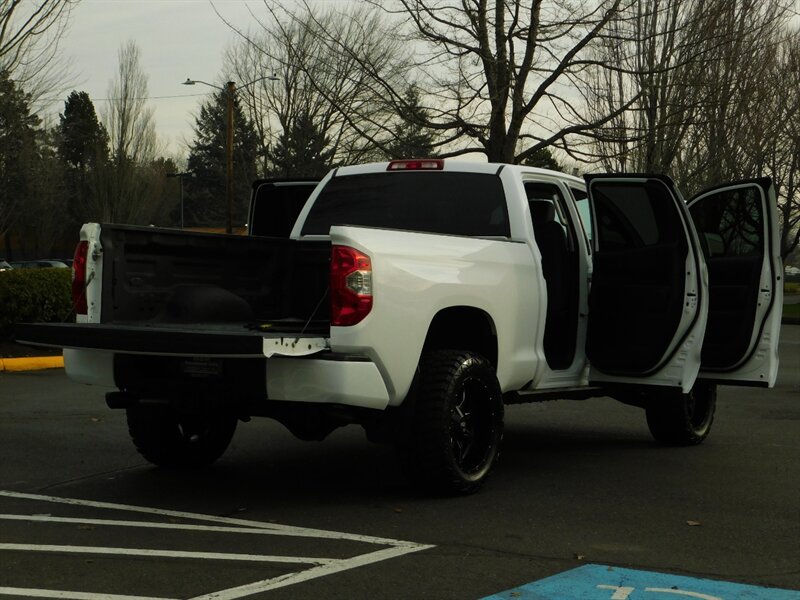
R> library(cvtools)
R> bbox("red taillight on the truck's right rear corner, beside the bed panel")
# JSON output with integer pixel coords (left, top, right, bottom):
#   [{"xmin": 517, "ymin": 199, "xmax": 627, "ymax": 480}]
[{"xmin": 331, "ymin": 246, "xmax": 372, "ymax": 327}]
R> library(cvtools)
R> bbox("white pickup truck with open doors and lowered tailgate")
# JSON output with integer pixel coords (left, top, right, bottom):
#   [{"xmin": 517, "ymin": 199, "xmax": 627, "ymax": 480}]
[{"xmin": 17, "ymin": 160, "xmax": 782, "ymax": 493}]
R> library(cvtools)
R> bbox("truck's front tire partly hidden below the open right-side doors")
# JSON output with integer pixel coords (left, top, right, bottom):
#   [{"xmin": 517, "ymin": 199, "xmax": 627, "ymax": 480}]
[{"xmin": 646, "ymin": 382, "xmax": 717, "ymax": 446}]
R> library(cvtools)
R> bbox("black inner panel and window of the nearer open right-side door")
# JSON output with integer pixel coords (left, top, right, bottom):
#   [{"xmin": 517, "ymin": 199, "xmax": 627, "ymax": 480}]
[{"xmin": 586, "ymin": 179, "xmax": 689, "ymax": 376}]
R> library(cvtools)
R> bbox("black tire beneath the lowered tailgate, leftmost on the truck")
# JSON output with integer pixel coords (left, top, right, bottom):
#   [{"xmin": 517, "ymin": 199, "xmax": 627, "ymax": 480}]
[{"xmin": 127, "ymin": 404, "xmax": 237, "ymax": 467}]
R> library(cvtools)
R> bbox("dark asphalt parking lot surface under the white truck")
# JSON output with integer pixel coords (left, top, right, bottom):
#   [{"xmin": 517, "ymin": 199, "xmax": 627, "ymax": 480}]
[{"xmin": 0, "ymin": 325, "xmax": 800, "ymax": 600}]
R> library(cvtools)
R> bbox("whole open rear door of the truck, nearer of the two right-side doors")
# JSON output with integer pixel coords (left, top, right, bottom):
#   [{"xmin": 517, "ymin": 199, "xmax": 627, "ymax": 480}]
[{"xmin": 586, "ymin": 175, "xmax": 708, "ymax": 392}]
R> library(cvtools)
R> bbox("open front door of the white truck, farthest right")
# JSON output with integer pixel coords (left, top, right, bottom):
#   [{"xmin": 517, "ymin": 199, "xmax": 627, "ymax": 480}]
[{"xmin": 688, "ymin": 178, "xmax": 783, "ymax": 387}]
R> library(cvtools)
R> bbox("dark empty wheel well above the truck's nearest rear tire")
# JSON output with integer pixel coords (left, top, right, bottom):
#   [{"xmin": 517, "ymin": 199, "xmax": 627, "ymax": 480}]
[{"xmin": 423, "ymin": 306, "xmax": 497, "ymax": 368}]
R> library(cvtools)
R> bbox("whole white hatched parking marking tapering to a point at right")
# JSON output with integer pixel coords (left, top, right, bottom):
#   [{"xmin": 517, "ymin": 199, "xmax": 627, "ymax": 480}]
[{"xmin": 0, "ymin": 490, "xmax": 433, "ymax": 600}]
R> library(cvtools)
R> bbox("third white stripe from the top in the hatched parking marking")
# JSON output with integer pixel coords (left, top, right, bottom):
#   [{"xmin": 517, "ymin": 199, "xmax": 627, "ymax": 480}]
[{"xmin": 0, "ymin": 544, "xmax": 334, "ymax": 565}]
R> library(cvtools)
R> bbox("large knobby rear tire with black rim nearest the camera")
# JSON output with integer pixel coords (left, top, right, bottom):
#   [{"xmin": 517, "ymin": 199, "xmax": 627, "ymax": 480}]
[{"xmin": 404, "ymin": 350, "xmax": 503, "ymax": 494}]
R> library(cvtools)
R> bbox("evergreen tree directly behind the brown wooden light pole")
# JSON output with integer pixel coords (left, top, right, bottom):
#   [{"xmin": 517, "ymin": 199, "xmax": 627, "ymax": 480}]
[{"xmin": 184, "ymin": 90, "xmax": 259, "ymax": 227}]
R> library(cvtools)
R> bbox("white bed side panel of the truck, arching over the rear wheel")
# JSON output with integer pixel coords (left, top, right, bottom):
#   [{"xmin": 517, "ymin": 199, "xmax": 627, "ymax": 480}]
[{"xmin": 324, "ymin": 227, "xmax": 544, "ymax": 405}]
